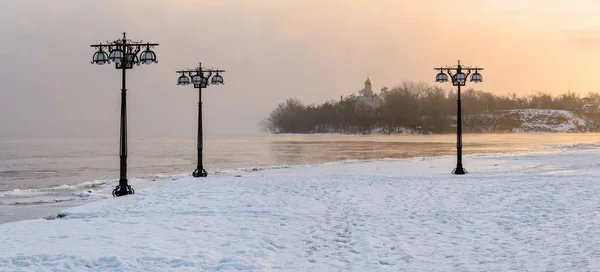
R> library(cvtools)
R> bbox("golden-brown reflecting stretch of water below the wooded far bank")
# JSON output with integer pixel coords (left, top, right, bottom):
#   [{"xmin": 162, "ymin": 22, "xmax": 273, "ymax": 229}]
[{"xmin": 264, "ymin": 134, "xmax": 600, "ymax": 164}]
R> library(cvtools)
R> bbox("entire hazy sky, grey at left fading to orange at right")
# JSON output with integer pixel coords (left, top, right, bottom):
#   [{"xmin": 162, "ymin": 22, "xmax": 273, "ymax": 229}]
[{"xmin": 0, "ymin": 0, "xmax": 600, "ymax": 138}]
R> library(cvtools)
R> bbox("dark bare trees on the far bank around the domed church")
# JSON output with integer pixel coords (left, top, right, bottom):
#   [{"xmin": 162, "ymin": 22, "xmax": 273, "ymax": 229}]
[{"xmin": 260, "ymin": 81, "xmax": 600, "ymax": 134}]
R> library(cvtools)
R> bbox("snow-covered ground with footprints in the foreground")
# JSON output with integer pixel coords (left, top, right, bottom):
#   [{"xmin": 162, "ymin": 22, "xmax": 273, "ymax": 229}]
[{"xmin": 0, "ymin": 148, "xmax": 600, "ymax": 271}]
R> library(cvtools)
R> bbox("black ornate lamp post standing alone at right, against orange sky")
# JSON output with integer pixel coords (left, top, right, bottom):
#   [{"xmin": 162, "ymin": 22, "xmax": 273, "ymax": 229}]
[{"xmin": 434, "ymin": 60, "xmax": 483, "ymax": 175}]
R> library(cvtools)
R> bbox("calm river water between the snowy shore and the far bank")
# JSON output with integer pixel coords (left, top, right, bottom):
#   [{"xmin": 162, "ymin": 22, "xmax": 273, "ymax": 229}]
[{"xmin": 0, "ymin": 133, "xmax": 600, "ymax": 191}]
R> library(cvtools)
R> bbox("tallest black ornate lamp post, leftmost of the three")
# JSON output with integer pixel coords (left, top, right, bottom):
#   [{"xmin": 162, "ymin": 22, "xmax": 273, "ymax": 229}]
[{"xmin": 90, "ymin": 33, "xmax": 158, "ymax": 196}]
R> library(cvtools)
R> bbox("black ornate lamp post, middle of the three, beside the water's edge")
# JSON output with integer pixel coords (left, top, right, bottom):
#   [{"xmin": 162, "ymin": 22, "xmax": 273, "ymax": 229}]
[{"xmin": 175, "ymin": 63, "xmax": 225, "ymax": 178}]
